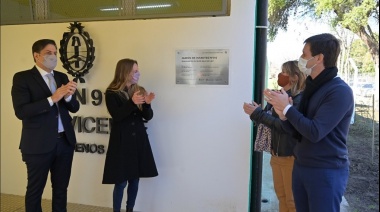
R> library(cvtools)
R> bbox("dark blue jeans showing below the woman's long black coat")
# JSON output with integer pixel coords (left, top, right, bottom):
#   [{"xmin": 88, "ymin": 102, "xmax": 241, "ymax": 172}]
[{"xmin": 113, "ymin": 178, "xmax": 140, "ymax": 212}]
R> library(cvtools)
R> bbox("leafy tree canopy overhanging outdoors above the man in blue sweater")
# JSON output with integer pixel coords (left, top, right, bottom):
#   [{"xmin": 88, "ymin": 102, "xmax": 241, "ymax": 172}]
[{"xmin": 268, "ymin": 0, "xmax": 379, "ymax": 73}]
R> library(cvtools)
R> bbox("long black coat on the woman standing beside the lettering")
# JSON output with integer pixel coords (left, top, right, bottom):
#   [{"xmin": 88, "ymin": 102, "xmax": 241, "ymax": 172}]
[{"xmin": 103, "ymin": 90, "xmax": 158, "ymax": 184}]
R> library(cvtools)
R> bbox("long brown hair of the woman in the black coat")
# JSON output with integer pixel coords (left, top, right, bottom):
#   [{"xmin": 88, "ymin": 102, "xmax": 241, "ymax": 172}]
[{"xmin": 107, "ymin": 58, "xmax": 138, "ymax": 98}]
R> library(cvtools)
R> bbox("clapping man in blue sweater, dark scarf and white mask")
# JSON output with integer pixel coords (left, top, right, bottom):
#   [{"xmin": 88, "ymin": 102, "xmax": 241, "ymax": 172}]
[{"xmin": 264, "ymin": 34, "xmax": 354, "ymax": 212}]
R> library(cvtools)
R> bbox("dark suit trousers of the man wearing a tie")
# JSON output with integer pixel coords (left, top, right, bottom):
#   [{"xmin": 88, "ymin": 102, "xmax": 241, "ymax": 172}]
[{"xmin": 22, "ymin": 136, "xmax": 74, "ymax": 212}]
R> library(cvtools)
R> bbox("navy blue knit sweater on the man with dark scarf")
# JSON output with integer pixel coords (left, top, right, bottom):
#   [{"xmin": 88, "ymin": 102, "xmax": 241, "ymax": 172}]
[{"xmin": 283, "ymin": 77, "xmax": 354, "ymax": 168}]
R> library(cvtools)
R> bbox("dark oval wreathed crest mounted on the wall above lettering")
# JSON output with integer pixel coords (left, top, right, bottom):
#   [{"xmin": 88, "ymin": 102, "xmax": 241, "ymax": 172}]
[{"xmin": 59, "ymin": 22, "xmax": 95, "ymax": 83}]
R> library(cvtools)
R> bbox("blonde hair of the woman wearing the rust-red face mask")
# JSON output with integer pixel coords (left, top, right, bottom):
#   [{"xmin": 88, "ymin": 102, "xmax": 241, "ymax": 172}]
[{"xmin": 281, "ymin": 60, "xmax": 306, "ymax": 96}]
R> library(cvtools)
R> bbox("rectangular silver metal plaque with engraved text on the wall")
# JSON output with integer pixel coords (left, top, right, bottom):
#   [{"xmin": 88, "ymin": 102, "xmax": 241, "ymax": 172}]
[{"xmin": 176, "ymin": 49, "xmax": 229, "ymax": 85}]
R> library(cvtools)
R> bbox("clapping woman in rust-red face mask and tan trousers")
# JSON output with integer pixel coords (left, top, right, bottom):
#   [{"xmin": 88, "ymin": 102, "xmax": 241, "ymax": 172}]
[{"xmin": 243, "ymin": 61, "xmax": 306, "ymax": 212}]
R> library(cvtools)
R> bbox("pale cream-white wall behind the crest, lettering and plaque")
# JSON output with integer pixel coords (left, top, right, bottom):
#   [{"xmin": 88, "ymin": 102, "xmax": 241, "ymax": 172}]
[{"xmin": 1, "ymin": 0, "xmax": 255, "ymax": 212}]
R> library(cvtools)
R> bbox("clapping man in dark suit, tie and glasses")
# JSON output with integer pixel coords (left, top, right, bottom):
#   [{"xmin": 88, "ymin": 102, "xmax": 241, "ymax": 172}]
[{"xmin": 12, "ymin": 39, "xmax": 79, "ymax": 212}]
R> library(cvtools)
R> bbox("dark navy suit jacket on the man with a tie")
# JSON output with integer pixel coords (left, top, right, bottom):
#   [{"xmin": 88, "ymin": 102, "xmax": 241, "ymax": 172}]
[{"xmin": 12, "ymin": 67, "xmax": 79, "ymax": 154}]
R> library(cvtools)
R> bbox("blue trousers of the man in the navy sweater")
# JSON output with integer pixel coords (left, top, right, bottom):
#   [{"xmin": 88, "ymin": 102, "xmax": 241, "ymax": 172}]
[{"xmin": 292, "ymin": 163, "xmax": 349, "ymax": 212}]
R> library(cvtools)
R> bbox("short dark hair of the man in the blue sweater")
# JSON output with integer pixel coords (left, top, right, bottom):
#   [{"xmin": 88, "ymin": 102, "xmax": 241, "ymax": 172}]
[{"xmin": 304, "ymin": 33, "xmax": 340, "ymax": 68}]
